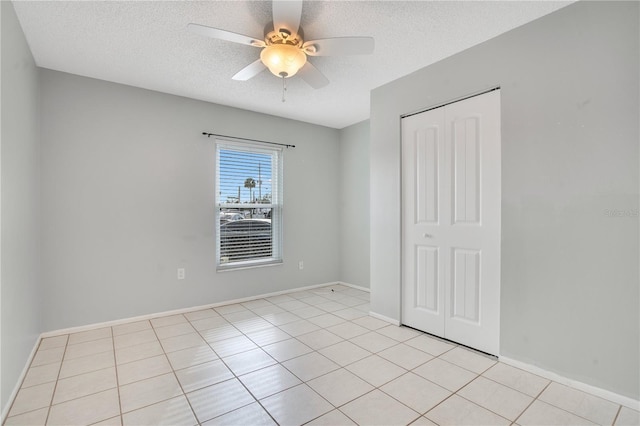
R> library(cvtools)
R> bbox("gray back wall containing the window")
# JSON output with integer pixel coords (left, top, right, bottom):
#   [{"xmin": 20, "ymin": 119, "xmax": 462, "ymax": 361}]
[{"xmin": 40, "ymin": 70, "xmax": 340, "ymax": 330}]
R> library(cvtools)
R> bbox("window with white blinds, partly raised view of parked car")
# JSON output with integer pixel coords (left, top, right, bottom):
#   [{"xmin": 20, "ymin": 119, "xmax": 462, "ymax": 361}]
[{"xmin": 216, "ymin": 139, "xmax": 282, "ymax": 269}]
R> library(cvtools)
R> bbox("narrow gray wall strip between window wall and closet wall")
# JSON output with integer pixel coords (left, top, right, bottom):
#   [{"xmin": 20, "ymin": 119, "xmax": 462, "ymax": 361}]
[{"xmin": 340, "ymin": 120, "xmax": 369, "ymax": 287}]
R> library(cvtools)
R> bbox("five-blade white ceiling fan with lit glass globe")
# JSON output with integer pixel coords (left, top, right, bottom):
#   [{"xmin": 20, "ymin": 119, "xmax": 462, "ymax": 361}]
[{"xmin": 188, "ymin": 0, "xmax": 374, "ymax": 89}]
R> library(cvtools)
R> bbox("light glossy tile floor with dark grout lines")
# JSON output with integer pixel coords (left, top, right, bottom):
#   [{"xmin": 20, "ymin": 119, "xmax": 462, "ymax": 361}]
[{"xmin": 5, "ymin": 285, "xmax": 640, "ymax": 426}]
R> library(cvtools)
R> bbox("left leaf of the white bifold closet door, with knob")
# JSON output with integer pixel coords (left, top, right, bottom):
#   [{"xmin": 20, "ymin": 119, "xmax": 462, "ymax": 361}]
[{"xmin": 402, "ymin": 108, "xmax": 449, "ymax": 336}]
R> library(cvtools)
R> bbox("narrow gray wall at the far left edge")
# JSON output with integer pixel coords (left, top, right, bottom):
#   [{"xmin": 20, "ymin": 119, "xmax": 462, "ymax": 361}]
[{"xmin": 0, "ymin": 1, "xmax": 41, "ymax": 409}]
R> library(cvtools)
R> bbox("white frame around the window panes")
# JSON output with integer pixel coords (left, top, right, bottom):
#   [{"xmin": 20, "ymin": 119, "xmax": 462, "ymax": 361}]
[{"xmin": 214, "ymin": 137, "xmax": 284, "ymax": 271}]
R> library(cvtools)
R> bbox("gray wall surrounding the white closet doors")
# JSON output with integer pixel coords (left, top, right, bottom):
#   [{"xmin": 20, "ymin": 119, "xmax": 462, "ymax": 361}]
[{"xmin": 371, "ymin": 2, "xmax": 640, "ymax": 399}]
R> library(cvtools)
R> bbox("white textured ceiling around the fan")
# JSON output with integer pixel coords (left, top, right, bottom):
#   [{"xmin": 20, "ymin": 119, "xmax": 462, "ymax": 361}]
[{"xmin": 13, "ymin": 1, "xmax": 571, "ymax": 129}]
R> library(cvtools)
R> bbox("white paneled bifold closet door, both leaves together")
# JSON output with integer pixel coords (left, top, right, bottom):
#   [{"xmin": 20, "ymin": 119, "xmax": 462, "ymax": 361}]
[{"xmin": 402, "ymin": 91, "xmax": 501, "ymax": 354}]
